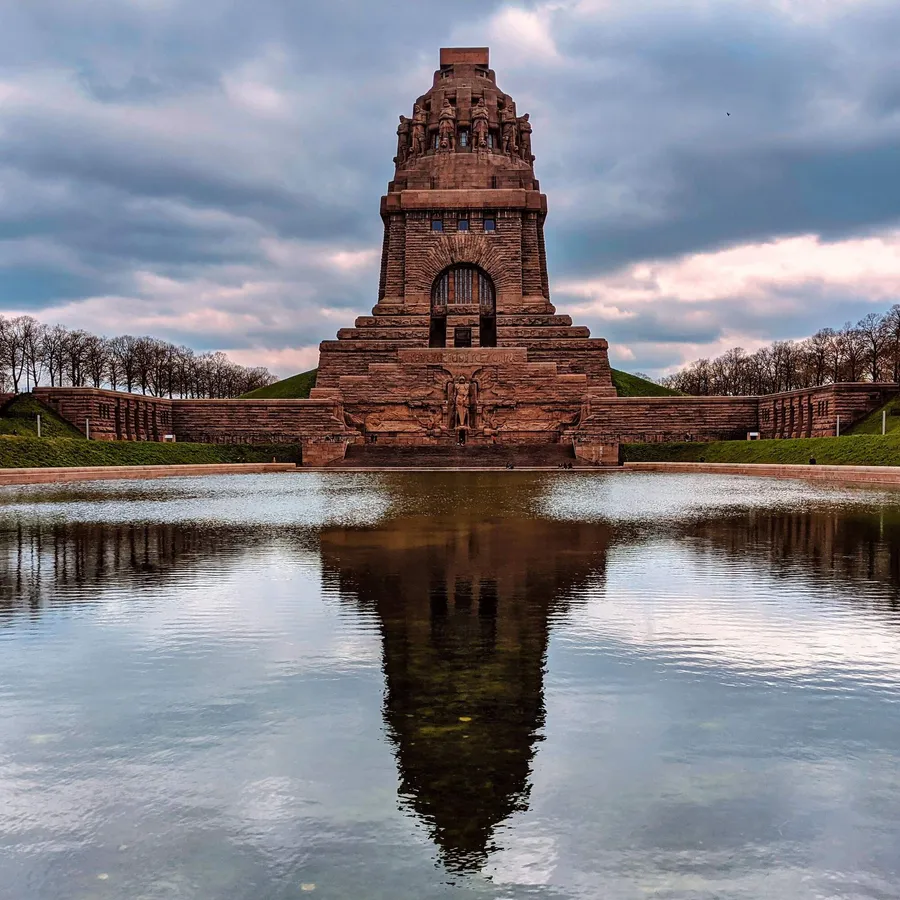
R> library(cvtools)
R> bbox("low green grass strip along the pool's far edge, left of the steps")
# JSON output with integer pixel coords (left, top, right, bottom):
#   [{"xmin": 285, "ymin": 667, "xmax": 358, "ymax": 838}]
[{"xmin": 0, "ymin": 436, "xmax": 300, "ymax": 469}]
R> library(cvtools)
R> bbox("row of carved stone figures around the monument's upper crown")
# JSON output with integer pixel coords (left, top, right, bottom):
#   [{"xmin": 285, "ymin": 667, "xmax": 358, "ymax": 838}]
[{"xmin": 394, "ymin": 97, "xmax": 534, "ymax": 166}]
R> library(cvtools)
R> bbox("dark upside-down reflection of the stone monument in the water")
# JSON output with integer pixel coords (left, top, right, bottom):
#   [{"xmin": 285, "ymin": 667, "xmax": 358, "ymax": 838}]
[{"xmin": 321, "ymin": 508, "xmax": 609, "ymax": 870}]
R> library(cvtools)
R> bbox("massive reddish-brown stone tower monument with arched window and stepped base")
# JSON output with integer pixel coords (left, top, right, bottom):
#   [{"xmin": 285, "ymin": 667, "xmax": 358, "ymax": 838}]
[{"xmin": 312, "ymin": 48, "xmax": 615, "ymax": 444}]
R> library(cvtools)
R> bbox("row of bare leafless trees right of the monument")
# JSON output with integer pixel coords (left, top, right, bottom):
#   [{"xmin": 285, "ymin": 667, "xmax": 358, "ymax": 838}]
[{"xmin": 660, "ymin": 304, "xmax": 900, "ymax": 396}]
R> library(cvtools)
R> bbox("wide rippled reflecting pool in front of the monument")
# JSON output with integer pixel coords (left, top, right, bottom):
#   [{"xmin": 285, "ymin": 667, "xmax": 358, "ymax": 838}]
[{"xmin": 0, "ymin": 472, "xmax": 900, "ymax": 900}]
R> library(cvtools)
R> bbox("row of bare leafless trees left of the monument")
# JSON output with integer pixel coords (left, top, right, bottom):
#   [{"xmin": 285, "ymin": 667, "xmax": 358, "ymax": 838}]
[{"xmin": 0, "ymin": 315, "xmax": 276, "ymax": 397}]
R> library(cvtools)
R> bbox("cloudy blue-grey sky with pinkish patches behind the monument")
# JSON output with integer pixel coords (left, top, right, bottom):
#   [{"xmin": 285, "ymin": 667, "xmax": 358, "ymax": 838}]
[{"xmin": 0, "ymin": 0, "xmax": 900, "ymax": 375}]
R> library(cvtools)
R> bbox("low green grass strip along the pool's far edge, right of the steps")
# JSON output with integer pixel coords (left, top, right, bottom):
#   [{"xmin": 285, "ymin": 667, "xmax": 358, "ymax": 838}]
[{"xmin": 622, "ymin": 432, "xmax": 900, "ymax": 466}]
